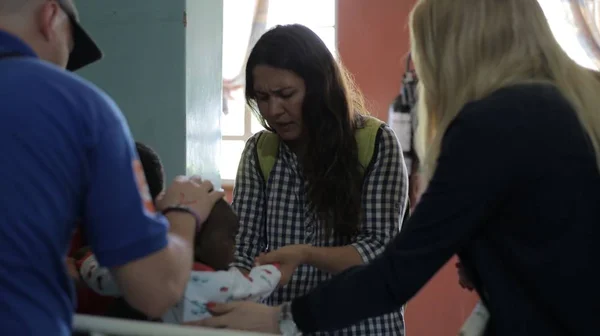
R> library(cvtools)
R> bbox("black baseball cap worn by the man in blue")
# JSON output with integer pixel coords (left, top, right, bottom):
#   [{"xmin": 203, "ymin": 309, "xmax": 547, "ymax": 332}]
[{"xmin": 58, "ymin": 0, "xmax": 102, "ymax": 71}]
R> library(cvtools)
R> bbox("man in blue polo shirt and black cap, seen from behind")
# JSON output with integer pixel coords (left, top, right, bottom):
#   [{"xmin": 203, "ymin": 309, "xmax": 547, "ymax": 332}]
[{"xmin": 0, "ymin": 0, "xmax": 223, "ymax": 336}]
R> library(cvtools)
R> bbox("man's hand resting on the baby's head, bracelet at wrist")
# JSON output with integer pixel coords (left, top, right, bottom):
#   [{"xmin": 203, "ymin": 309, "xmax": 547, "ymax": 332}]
[{"xmin": 157, "ymin": 176, "xmax": 225, "ymax": 223}]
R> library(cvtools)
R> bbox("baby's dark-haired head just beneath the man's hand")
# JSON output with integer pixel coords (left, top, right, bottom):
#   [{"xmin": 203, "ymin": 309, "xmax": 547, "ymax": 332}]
[{"xmin": 194, "ymin": 199, "xmax": 239, "ymax": 270}]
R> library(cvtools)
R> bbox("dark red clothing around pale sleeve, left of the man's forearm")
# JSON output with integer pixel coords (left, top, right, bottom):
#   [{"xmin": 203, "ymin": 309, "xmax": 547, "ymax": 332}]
[{"xmin": 69, "ymin": 228, "xmax": 115, "ymax": 315}]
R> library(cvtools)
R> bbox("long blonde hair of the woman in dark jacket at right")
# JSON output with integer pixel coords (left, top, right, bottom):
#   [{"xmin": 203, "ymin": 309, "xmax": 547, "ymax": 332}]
[{"xmin": 410, "ymin": 0, "xmax": 600, "ymax": 183}]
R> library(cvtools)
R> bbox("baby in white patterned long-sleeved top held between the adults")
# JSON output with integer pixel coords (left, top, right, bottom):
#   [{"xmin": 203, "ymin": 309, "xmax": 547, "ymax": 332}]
[{"xmin": 76, "ymin": 142, "xmax": 281, "ymax": 323}]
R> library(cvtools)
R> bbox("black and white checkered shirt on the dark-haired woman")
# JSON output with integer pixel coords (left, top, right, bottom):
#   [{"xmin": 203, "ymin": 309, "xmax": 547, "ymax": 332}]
[{"xmin": 233, "ymin": 124, "xmax": 408, "ymax": 335}]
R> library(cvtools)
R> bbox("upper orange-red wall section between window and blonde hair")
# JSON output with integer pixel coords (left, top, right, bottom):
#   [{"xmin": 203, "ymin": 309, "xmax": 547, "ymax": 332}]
[{"xmin": 337, "ymin": 0, "xmax": 414, "ymax": 120}]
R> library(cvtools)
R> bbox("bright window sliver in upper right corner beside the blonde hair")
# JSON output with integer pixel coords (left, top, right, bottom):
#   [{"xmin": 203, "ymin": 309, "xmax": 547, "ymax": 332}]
[{"xmin": 538, "ymin": 0, "xmax": 597, "ymax": 70}]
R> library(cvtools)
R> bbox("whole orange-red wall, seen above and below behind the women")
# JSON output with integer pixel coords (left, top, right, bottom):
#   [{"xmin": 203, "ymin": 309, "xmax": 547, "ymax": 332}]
[{"xmin": 227, "ymin": 0, "xmax": 477, "ymax": 336}]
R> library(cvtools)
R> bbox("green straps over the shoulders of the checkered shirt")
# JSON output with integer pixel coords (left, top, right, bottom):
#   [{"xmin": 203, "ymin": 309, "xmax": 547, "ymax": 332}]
[{"xmin": 256, "ymin": 117, "xmax": 383, "ymax": 183}]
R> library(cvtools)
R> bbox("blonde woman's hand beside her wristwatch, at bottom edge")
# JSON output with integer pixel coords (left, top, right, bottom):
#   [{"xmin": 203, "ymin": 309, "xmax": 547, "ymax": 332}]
[{"xmin": 187, "ymin": 301, "xmax": 281, "ymax": 335}]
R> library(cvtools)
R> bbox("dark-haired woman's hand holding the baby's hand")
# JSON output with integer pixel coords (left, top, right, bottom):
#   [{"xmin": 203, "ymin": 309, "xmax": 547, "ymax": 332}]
[{"xmin": 256, "ymin": 244, "xmax": 310, "ymax": 286}]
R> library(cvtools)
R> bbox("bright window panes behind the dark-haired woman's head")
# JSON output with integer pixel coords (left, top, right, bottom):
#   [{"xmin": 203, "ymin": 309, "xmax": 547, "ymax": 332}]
[{"xmin": 219, "ymin": 0, "xmax": 337, "ymax": 184}]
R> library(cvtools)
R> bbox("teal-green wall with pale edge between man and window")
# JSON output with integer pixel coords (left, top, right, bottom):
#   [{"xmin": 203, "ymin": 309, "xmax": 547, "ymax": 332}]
[{"xmin": 77, "ymin": 0, "xmax": 223, "ymax": 184}]
